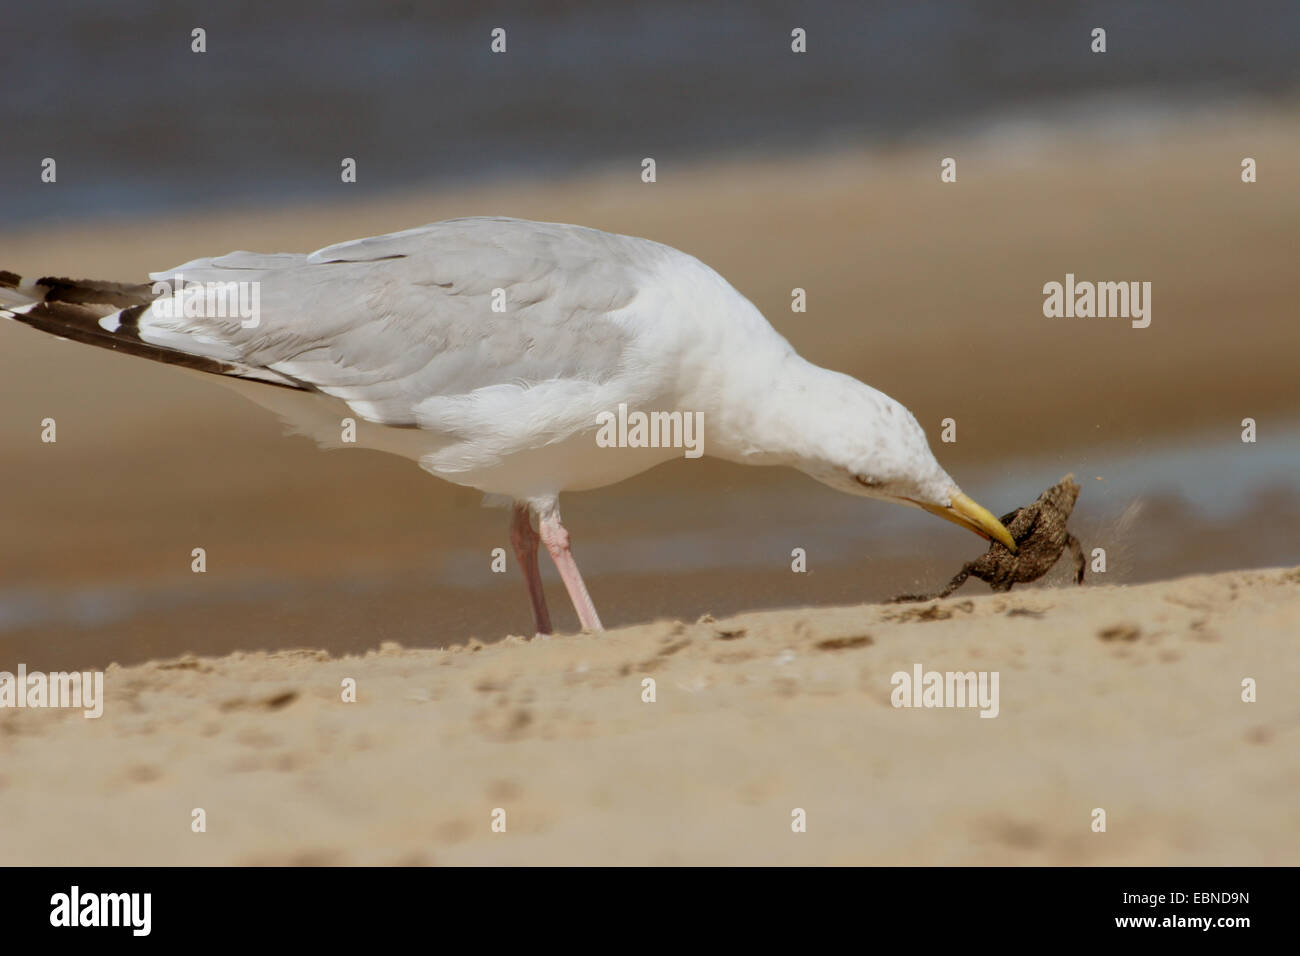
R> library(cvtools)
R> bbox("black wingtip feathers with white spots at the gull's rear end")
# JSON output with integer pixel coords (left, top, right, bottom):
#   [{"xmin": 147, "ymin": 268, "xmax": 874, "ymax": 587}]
[{"xmin": 0, "ymin": 269, "xmax": 303, "ymax": 389}]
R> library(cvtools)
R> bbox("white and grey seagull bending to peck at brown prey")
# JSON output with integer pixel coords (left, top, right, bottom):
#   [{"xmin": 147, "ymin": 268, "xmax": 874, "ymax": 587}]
[{"xmin": 0, "ymin": 217, "xmax": 1015, "ymax": 635}]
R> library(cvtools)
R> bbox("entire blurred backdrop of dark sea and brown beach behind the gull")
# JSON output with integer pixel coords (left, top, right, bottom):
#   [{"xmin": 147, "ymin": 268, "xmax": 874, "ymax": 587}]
[{"xmin": 0, "ymin": 0, "xmax": 1300, "ymax": 669}]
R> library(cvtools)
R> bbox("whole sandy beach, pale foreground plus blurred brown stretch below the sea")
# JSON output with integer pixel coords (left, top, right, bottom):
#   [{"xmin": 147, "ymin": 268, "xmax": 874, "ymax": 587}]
[{"xmin": 0, "ymin": 112, "xmax": 1300, "ymax": 865}]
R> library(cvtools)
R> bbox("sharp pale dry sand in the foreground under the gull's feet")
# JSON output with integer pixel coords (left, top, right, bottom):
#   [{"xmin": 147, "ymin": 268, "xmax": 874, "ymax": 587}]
[{"xmin": 0, "ymin": 568, "xmax": 1300, "ymax": 865}]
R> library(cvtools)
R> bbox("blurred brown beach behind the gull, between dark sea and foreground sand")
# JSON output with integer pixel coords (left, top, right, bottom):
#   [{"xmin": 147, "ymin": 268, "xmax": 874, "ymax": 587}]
[{"xmin": 0, "ymin": 112, "xmax": 1300, "ymax": 658}]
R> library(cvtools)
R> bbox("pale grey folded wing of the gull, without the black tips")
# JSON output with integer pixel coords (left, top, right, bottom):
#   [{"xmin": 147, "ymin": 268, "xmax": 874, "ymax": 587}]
[{"xmin": 140, "ymin": 219, "xmax": 655, "ymax": 425}]
